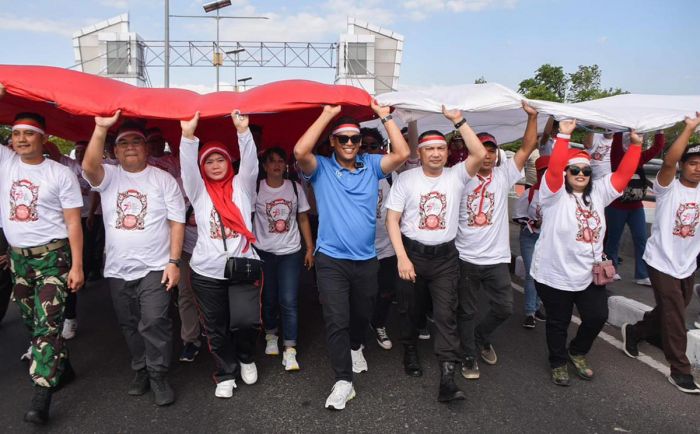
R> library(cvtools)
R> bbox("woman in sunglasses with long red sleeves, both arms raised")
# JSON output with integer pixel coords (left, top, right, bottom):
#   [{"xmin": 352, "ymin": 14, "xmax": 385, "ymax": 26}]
[{"xmin": 530, "ymin": 120, "xmax": 642, "ymax": 386}]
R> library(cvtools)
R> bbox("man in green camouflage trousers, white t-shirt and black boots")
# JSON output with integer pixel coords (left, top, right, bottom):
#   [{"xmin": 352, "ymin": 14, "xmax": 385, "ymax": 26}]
[{"xmin": 0, "ymin": 85, "xmax": 83, "ymax": 424}]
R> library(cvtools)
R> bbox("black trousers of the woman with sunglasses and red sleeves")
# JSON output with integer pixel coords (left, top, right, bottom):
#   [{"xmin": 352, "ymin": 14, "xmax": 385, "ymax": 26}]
[{"xmin": 535, "ymin": 281, "xmax": 608, "ymax": 368}]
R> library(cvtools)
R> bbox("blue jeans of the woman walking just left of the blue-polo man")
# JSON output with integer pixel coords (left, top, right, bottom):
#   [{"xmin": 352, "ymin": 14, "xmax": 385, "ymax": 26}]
[{"xmin": 258, "ymin": 250, "xmax": 304, "ymax": 347}]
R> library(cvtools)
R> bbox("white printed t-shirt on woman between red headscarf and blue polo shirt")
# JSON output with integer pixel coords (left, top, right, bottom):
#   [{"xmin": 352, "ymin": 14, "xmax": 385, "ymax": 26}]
[{"xmin": 253, "ymin": 179, "xmax": 310, "ymax": 255}]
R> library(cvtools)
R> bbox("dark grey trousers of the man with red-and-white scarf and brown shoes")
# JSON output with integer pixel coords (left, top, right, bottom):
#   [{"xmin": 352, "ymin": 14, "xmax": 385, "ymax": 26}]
[{"xmin": 457, "ymin": 260, "xmax": 513, "ymax": 357}]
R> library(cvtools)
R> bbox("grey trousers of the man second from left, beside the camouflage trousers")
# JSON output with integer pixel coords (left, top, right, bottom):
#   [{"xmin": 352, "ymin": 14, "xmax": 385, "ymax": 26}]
[{"xmin": 107, "ymin": 271, "xmax": 173, "ymax": 372}]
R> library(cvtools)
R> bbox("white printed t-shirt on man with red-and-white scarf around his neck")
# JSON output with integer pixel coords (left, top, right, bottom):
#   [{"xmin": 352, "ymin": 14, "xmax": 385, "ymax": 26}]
[{"xmin": 455, "ymin": 159, "xmax": 523, "ymax": 265}]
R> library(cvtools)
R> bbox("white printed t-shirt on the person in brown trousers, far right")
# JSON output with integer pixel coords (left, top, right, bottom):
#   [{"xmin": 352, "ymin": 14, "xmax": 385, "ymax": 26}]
[{"xmin": 644, "ymin": 179, "xmax": 700, "ymax": 279}]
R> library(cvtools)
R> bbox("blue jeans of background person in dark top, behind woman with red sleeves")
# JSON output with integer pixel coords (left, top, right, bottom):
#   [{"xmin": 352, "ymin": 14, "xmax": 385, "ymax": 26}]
[{"xmin": 605, "ymin": 206, "xmax": 649, "ymax": 279}]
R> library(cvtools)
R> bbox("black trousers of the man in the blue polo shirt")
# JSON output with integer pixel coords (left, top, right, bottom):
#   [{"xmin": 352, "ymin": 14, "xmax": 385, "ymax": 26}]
[{"xmin": 316, "ymin": 252, "xmax": 379, "ymax": 381}]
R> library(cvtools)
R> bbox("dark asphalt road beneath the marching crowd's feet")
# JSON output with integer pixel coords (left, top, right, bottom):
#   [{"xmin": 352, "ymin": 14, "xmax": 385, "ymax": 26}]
[{"xmin": 0, "ymin": 274, "xmax": 700, "ymax": 433}]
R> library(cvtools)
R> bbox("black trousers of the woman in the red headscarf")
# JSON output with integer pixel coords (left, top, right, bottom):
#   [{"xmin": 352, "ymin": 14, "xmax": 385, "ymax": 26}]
[{"xmin": 192, "ymin": 271, "xmax": 261, "ymax": 383}]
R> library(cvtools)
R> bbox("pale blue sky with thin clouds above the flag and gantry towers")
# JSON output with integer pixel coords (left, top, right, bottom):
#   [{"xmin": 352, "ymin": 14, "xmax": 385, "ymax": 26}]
[{"xmin": 0, "ymin": 0, "xmax": 700, "ymax": 94}]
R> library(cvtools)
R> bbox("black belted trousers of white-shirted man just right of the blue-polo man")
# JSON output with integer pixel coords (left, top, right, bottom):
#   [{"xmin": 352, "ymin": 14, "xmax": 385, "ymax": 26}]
[{"xmin": 397, "ymin": 245, "xmax": 460, "ymax": 362}]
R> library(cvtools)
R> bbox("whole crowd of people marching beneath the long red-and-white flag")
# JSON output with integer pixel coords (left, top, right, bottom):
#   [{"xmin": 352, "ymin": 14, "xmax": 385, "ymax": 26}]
[{"xmin": 0, "ymin": 81, "xmax": 700, "ymax": 424}]
